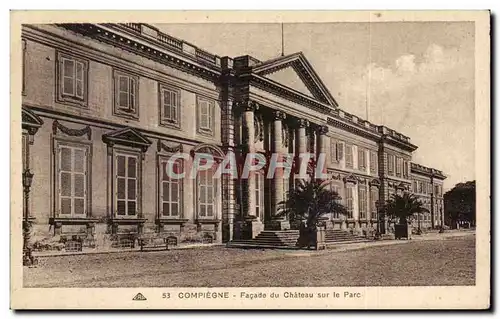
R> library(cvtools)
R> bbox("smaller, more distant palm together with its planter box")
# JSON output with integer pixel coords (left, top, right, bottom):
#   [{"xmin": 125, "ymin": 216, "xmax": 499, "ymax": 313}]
[{"xmin": 385, "ymin": 193, "xmax": 423, "ymax": 239}]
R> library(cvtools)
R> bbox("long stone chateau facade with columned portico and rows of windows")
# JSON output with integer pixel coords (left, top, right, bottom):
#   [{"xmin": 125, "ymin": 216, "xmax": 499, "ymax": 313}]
[{"xmin": 22, "ymin": 23, "xmax": 445, "ymax": 249}]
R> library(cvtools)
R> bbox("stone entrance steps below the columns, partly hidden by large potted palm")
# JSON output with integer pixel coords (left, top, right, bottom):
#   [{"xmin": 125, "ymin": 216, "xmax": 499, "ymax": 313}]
[{"xmin": 227, "ymin": 229, "xmax": 370, "ymax": 249}]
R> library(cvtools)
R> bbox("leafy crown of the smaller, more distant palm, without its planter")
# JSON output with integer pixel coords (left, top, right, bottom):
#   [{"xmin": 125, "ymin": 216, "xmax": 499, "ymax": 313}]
[{"xmin": 385, "ymin": 193, "xmax": 424, "ymax": 224}]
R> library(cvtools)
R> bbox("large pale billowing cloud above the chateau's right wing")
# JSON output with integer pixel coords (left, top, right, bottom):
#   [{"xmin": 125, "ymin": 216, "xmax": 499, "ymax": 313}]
[{"xmin": 339, "ymin": 44, "xmax": 474, "ymax": 187}]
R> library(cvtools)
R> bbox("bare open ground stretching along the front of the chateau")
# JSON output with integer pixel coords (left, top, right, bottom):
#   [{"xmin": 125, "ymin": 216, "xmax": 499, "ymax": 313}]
[{"xmin": 24, "ymin": 233, "xmax": 475, "ymax": 287}]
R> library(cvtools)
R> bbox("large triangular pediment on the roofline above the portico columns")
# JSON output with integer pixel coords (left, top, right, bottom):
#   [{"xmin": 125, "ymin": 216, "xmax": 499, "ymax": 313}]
[{"xmin": 253, "ymin": 52, "xmax": 338, "ymax": 107}]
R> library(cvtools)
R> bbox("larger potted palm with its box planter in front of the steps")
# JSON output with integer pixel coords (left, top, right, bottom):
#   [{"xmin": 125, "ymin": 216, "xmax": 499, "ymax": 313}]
[{"xmin": 278, "ymin": 179, "xmax": 347, "ymax": 249}]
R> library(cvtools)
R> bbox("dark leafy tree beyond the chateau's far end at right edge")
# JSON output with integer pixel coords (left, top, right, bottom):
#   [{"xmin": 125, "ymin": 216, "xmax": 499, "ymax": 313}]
[{"xmin": 444, "ymin": 181, "xmax": 476, "ymax": 225}]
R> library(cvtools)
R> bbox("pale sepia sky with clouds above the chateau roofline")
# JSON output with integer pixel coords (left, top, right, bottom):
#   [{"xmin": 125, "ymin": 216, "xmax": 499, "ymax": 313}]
[{"xmin": 156, "ymin": 22, "xmax": 475, "ymax": 189}]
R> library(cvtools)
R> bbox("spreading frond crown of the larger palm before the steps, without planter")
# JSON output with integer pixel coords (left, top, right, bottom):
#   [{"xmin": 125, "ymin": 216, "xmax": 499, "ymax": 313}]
[{"xmin": 278, "ymin": 179, "xmax": 347, "ymax": 229}]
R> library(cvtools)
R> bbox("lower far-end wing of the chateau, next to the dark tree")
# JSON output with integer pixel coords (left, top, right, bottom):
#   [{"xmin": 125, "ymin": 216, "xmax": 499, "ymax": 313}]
[{"xmin": 411, "ymin": 163, "xmax": 446, "ymax": 229}]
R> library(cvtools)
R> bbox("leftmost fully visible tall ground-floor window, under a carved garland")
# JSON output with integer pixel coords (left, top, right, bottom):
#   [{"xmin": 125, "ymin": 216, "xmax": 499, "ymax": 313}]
[{"xmin": 56, "ymin": 144, "xmax": 89, "ymax": 217}]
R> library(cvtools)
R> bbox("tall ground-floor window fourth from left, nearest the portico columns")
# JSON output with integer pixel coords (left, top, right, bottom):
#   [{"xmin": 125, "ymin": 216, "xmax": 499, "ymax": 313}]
[{"xmin": 197, "ymin": 169, "xmax": 216, "ymax": 218}]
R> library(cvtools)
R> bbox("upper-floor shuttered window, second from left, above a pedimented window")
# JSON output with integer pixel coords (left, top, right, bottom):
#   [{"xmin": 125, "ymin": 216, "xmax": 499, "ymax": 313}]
[{"xmin": 113, "ymin": 71, "xmax": 139, "ymax": 118}]
